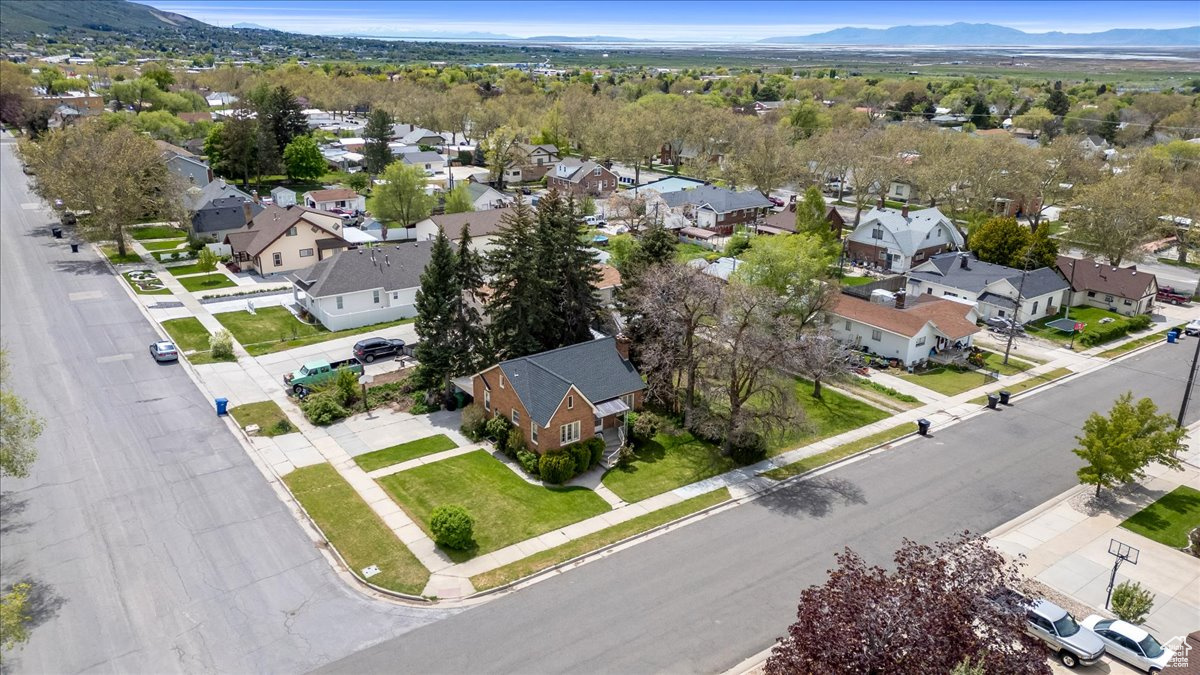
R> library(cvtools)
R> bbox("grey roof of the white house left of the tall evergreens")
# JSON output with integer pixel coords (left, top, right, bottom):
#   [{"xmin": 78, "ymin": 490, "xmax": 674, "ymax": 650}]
[{"xmin": 288, "ymin": 241, "xmax": 433, "ymax": 298}]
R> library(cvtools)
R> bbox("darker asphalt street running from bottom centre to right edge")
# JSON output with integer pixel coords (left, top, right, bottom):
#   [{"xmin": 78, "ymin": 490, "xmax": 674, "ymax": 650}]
[{"xmin": 323, "ymin": 342, "xmax": 1200, "ymax": 673}]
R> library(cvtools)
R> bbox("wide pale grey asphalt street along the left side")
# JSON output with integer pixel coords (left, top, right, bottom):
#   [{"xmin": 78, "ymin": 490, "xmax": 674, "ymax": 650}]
[{"xmin": 0, "ymin": 133, "xmax": 446, "ymax": 673}]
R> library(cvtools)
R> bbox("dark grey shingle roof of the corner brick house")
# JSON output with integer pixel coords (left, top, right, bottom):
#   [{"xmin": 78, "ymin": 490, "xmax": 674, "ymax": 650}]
[{"xmin": 490, "ymin": 338, "xmax": 646, "ymax": 426}]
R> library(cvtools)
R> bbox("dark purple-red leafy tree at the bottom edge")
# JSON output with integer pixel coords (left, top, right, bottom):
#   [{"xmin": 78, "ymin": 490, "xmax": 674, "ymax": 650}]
[{"xmin": 766, "ymin": 532, "xmax": 1050, "ymax": 675}]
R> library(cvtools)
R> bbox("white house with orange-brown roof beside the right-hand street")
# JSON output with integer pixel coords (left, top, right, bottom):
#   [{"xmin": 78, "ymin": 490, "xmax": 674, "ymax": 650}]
[{"xmin": 829, "ymin": 291, "xmax": 980, "ymax": 366}]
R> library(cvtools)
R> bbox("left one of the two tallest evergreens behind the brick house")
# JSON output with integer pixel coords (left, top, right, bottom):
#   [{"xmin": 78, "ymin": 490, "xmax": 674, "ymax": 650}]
[{"xmin": 485, "ymin": 195, "xmax": 548, "ymax": 359}]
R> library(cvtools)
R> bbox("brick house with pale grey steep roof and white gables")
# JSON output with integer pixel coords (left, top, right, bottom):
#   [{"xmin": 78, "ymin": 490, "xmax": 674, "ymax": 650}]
[{"xmin": 846, "ymin": 207, "xmax": 965, "ymax": 274}]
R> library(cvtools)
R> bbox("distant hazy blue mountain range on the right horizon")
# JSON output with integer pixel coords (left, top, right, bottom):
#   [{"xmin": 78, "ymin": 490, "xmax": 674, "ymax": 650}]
[{"xmin": 758, "ymin": 23, "xmax": 1200, "ymax": 47}]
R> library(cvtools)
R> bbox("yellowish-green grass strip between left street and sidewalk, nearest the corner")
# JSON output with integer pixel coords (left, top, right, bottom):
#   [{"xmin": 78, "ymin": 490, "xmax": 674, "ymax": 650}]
[{"xmin": 283, "ymin": 464, "xmax": 430, "ymax": 595}]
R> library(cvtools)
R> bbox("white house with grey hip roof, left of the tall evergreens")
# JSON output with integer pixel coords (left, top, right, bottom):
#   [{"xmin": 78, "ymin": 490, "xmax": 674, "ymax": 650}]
[{"xmin": 288, "ymin": 241, "xmax": 433, "ymax": 330}]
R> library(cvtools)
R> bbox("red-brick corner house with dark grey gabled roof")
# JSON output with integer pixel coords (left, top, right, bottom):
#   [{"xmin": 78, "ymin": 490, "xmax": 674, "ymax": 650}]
[{"xmin": 472, "ymin": 338, "xmax": 646, "ymax": 454}]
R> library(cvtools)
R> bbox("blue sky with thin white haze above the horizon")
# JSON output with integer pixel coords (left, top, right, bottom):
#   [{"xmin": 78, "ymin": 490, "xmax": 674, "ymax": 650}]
[{"xmin": 140, "ymin": 0, "xmax": 1200, "ymax": 41}]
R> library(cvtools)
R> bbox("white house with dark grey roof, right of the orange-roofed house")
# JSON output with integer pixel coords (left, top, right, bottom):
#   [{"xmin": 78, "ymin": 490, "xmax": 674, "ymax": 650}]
[{"xmin": 908, "ymin": 252, "xmax": 1070, "ymax": 323}]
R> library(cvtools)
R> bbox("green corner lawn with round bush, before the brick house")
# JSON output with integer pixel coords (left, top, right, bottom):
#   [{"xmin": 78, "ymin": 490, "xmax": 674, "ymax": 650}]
[{"xmin": 379, "ymin": 450, "xmax": 610, "ymax": 562}]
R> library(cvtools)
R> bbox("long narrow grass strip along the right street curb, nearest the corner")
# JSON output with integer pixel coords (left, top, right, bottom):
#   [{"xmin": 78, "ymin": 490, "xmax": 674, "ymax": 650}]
[{"xmin": 470, "ymin": 488, "xmax": 730, "ymax": 591}]
